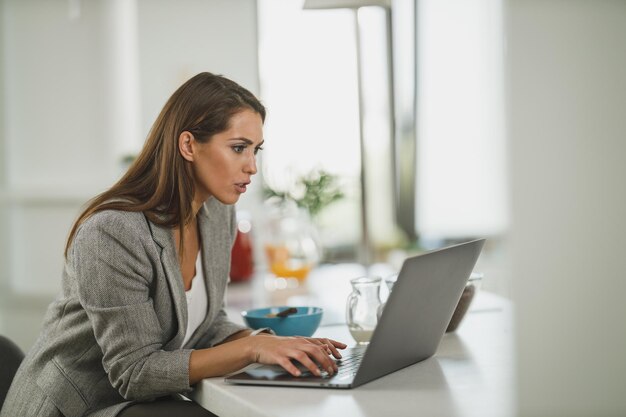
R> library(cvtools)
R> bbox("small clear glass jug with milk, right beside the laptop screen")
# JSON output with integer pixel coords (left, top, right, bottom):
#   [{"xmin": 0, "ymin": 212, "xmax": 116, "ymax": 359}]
[{"xmin": 346, "ymin": 276, "xmax": 382, "ymax": 345}]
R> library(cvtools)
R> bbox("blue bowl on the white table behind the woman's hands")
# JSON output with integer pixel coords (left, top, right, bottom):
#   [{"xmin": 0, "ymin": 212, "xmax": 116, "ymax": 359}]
[{"xmin": 241, "ymin": 306, "xmax": 324, "ymax": 337}]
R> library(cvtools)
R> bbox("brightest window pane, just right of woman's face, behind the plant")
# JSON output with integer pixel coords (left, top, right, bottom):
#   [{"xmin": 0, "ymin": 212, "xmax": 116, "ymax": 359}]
[{"xmin": 258, "ymin": 0, "xmax": 360, "ymax": 255}]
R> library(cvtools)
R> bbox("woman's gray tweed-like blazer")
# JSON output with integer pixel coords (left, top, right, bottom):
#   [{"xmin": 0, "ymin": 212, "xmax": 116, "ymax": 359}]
[{"xmin": 0, "ymin": 198, "xmax": 249, "ymax": 417}]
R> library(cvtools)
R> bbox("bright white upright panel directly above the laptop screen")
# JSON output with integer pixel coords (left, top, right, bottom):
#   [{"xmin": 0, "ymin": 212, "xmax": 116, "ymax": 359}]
[{"xmin": 415, "ymin": 0, "xmax": 509, "ymax": 239}]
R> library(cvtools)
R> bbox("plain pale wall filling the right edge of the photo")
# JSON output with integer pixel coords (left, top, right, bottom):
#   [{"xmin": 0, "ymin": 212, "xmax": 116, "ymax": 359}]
[{"xmin": 507, "ymin": 0, "xmax": 626, "ymax": 417}]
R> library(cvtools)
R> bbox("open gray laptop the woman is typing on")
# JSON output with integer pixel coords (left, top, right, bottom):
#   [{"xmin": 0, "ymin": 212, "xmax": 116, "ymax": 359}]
[{"xmin": 225, "ymin": 239, "xmax": 485, "ymax": 388}]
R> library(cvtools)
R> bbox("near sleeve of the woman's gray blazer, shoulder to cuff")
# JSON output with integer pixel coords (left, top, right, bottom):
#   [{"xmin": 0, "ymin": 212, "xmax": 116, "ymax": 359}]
[{"xmin": 69, "ymin": 212, "xmax": 191, "ymax": 400}]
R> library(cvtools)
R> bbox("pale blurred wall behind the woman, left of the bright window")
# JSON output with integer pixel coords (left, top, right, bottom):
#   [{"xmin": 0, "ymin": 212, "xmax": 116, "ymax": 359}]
[{"xmin": 0, "ymin": 0, "xmax": 259, "ymax": 300}]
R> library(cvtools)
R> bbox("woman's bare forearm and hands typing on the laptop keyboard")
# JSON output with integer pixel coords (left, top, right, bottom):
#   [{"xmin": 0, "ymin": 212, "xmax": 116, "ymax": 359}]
[{"xmin": 189, "ymin": 330, "xmax": 346, "ymax": 385}]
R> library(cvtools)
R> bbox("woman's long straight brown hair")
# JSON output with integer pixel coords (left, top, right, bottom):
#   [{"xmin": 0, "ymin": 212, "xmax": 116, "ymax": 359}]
[{"xmin": 65, "ymin": 72, "xmax": 265, "ymax": 257}]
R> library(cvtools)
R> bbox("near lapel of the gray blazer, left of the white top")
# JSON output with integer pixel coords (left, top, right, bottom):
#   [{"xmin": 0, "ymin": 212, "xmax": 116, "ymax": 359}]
[{"xmin": 148, "ymin": 216, "xmax": 188, "ymax": 349}]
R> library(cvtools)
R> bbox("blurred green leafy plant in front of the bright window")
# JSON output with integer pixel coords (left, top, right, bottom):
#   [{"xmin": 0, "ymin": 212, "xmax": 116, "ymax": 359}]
[{"xmin": 263, "ymin": 170, "xmax": 344, "ymax": 217}]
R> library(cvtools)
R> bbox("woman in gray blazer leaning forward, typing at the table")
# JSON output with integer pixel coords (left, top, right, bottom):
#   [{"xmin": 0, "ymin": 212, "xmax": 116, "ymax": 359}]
[{"xmin": 1, "ymin": 73, "xmax": 345, "ymax": 417}]
